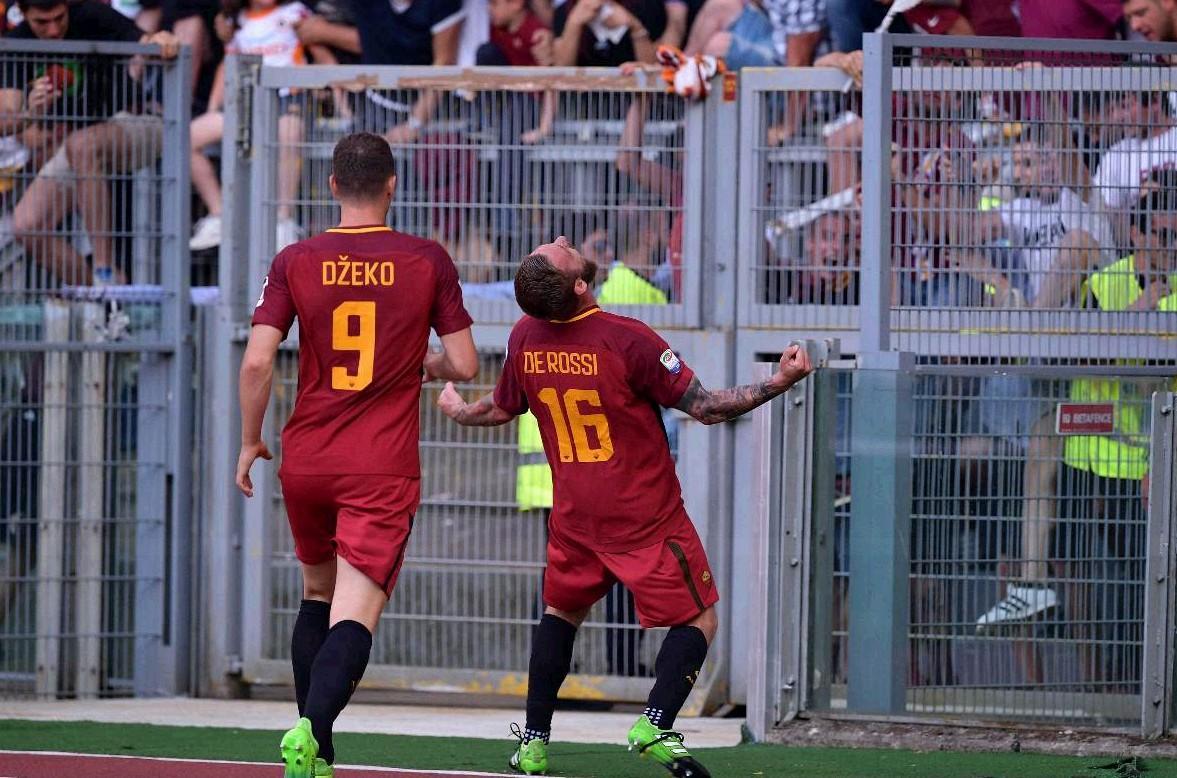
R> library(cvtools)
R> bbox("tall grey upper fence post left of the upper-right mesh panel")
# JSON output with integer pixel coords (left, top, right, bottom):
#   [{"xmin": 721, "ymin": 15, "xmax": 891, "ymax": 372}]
[{"xmin": 858, "ymin": 33, "xmax": 891, "ymax": 353}]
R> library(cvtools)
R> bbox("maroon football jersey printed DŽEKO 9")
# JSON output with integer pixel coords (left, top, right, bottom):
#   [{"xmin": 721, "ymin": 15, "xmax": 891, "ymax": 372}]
[{"xmin": 253, "ymin": 227, "xmax": 471, "ymax": 478}]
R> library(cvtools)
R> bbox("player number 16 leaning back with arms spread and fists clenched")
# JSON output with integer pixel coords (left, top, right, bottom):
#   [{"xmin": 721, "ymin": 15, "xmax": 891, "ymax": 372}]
[{"xmin": 438, "ymin": 238, "xmax": 812, "ymax": 778}]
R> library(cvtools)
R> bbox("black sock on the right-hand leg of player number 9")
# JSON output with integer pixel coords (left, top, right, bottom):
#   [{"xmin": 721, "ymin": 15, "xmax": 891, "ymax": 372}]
[{"xmin": 305, "ymin": 620, "xmax": 372, "ymax": 764}]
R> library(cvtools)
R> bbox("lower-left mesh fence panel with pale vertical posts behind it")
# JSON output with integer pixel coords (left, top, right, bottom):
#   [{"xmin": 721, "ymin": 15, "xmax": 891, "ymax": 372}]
[{"xmin": 0, "ymin": 338, "xmax": 166, "ymax": 698}]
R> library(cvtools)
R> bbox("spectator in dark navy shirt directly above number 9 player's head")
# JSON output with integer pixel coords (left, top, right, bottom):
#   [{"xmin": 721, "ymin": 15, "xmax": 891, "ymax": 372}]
[{"xmin": 352, "ymin": 0, "xmax": 465, "ymax": 145}]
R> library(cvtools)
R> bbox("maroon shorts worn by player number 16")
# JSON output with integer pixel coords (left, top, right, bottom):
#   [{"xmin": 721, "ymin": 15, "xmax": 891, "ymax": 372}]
[{"xmin": 544, "ymin": 511, "xmax": 719, "ymax": 627}]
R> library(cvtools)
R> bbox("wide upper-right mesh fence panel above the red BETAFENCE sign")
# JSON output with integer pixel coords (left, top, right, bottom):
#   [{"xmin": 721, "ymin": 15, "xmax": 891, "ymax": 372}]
[{"xmin": 879, "ymin": 38, "xmax": 1177, "ymax": 360}]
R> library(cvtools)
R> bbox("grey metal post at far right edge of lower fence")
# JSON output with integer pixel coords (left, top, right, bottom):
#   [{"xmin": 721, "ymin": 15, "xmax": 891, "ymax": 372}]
[{"xmin": 1141, "ymin": 392, "xmax": 1177, "ymax": 738}]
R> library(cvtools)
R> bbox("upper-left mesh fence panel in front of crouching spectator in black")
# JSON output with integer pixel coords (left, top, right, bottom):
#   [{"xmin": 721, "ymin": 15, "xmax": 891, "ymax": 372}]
[{"xmin": 0, "ymin": 41, "xmax": 187, "ymax": 345}]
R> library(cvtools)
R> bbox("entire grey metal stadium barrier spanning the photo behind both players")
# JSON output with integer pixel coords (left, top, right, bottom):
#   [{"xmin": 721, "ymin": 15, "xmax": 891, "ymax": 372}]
[{"xmin": 0, "ymin": 36, "xmax": 1177, "ymax": 734}]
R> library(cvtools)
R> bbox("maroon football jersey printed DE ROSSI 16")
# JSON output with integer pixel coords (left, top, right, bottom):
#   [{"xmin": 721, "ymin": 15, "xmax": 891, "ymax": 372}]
[{"xmin": 494, "ymin": 307, "xmax": 694, "ymax": 552}]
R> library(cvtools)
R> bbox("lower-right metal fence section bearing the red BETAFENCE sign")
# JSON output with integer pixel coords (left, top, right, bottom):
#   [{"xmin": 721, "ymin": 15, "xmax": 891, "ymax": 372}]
[{"xmin": 740, "ymin": 368, "xmax": 1175, "ymax": 736}]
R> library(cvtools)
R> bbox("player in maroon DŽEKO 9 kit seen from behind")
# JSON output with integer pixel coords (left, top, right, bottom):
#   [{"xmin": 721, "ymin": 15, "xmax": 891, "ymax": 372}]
[{"xmin": 237, "ymin": 133, "xmax": 478, "ymax": 778}]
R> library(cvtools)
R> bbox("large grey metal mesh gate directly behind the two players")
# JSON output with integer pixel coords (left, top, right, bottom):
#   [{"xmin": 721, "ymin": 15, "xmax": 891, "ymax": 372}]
[{"xmin": 205, "ymin": 59, "xmax": 733, "ymax": 711}]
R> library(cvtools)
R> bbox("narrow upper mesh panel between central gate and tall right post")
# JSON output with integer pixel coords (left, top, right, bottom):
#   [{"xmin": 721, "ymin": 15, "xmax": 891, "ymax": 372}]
[{"xmin": 739, "ymin": 69, "xmax": 863, "ymax": 335}]
